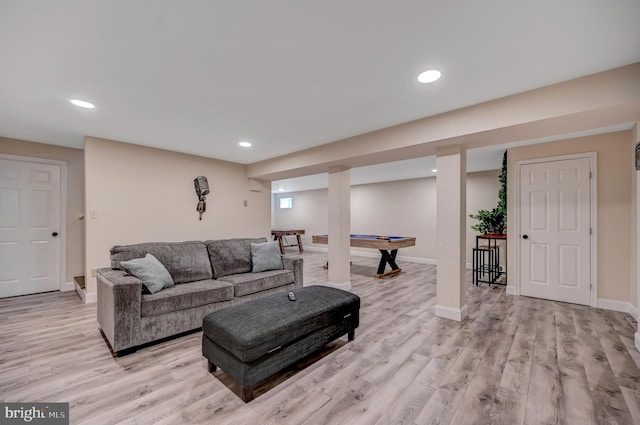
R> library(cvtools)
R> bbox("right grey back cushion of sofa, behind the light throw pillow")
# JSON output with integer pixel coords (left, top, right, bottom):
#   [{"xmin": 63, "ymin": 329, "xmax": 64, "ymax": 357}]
[{"xmin": 206, "ymin": 238, "xmax": 267, "ymax": 279}]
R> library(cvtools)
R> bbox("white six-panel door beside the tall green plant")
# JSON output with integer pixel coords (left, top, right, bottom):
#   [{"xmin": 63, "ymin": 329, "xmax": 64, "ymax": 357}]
[{"xmin": 519, "ymin": 158, "xmax": 591, "ymax": 305}]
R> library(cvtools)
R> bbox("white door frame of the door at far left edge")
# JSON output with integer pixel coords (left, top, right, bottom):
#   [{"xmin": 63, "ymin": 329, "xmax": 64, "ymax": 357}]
[{"xmin": 0, "ymin": 153, "xmax": 68, "ymax": 291}]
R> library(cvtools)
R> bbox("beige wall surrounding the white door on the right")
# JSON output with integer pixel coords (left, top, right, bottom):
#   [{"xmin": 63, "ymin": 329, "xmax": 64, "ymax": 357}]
[{"xmin": 507, "ymin": 131, "xmax": 635, "ymax": 302}]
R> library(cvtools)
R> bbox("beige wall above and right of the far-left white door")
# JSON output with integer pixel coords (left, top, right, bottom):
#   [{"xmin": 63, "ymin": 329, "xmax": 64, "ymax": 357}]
[{"xmin": 0, "ymin": 137, "xmax": 84, "ymax": 282}]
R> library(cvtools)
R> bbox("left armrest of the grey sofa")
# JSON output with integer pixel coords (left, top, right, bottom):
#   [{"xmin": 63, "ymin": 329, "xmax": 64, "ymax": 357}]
[{"xmin": 97, "ymin": 268, "xmax": 142, "ymax": 352}]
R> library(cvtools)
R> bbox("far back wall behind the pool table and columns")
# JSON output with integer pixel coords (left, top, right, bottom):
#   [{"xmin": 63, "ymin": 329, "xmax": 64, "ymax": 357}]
[{"xmin": 272, "ymin": 170, "xmax": 500, "ymax": 263}]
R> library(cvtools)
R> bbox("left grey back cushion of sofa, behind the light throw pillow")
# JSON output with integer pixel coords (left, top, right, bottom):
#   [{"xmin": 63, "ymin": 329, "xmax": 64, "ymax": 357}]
[{"xmin": 111, "ymin": 241, "xmax": 213, "ymax": 283}]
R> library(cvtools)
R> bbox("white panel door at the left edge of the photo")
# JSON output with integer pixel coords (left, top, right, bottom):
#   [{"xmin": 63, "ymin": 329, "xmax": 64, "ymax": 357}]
[{"xmin": 0, "ymin": 158, "xmax": 60, "ymax": 298}]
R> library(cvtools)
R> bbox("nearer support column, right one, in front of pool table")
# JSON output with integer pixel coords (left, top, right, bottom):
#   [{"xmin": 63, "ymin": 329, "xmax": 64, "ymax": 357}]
[{"xmin": 435, "ymin": 146, "xmax": 467, "ymax": 321}]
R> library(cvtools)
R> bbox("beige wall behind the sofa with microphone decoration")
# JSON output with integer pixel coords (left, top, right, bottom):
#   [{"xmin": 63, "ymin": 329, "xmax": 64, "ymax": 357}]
[{"xmin": 84, "ymin": 137, "xmax": 270, "ymax": 292}]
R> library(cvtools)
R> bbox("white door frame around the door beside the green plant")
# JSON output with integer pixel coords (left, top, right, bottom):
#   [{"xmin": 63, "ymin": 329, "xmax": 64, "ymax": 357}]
[{"xmin": 509, "ymin": 152, "xmax": 598, "ymax": 307}]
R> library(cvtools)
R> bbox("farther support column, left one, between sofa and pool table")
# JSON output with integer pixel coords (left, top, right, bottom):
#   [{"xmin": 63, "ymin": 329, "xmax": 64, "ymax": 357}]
[{"xmin": 327, "ymin": 167, "xmax": 351, "ymax": 290}]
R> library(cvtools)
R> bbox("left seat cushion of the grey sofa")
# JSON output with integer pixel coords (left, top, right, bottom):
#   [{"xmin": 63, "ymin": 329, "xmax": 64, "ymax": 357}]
[{"xmin": 140, "ymin": 279, "xmax": 233, "ymax": 316}]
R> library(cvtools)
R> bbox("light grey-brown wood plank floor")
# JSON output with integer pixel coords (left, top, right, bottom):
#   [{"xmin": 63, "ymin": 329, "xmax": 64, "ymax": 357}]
[{"xmin": 0, "ymin": 252, "xmax": 640, "ymax": 425}]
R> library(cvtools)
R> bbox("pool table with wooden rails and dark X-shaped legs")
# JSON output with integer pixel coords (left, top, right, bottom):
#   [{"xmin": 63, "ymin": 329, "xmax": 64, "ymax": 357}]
[{"xmin": 312, "ymin": 235, "xmax": 416, "ymax": 278}]
